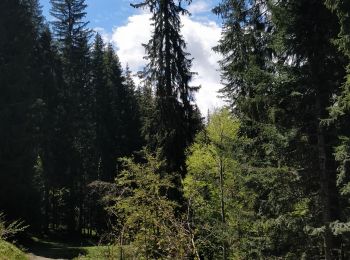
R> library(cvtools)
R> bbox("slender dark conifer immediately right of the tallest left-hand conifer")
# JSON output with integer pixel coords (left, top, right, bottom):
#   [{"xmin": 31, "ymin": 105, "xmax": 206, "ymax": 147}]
[{"xmin": 92, "ymin": 37, "xmax": 123, "ymax": 181}]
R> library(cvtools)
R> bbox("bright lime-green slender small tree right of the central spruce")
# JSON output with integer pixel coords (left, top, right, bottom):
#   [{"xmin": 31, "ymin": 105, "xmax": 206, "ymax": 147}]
[{"xmin": 184, "ymin": 109, "xmax": 239, "ymax": 259}]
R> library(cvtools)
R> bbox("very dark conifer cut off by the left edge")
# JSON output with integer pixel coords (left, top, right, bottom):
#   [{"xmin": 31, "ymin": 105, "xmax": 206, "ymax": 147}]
[{"xmin": 0, "ymin": 0, "xmax": 39, "ymax": 227}]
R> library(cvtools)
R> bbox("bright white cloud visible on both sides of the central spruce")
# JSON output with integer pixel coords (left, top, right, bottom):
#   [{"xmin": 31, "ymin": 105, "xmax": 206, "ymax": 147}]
[{"xmin": 111, "ymin": 11, "xmax": 223, "ymax": 115}]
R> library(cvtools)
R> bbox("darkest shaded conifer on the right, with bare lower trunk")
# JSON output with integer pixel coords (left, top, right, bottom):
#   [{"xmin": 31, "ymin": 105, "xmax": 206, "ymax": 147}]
[{"xmin": 274, "ymin": 1, "xmax": 344, "ymax": 259}]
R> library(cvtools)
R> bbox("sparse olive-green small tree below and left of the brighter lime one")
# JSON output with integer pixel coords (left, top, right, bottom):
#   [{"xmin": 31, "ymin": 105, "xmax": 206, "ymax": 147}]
[{"xmin": 111, "ymin": 151, "xmax": 189, "ymax": 259}]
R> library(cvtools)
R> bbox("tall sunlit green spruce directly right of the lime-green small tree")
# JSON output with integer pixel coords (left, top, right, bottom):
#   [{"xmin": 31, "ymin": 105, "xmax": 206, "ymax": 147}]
[{"xmin": 214, "ymin": 1, "xmax": 298, "ymax": 258}]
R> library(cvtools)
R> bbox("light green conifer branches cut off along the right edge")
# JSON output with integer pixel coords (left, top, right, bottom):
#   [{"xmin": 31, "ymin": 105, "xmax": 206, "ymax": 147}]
[{"xmin": 325, "ymin": 0, "xmax": 350, "ymax": 259}]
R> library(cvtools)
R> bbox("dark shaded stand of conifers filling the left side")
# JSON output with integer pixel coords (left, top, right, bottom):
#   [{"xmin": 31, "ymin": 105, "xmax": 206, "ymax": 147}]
[{"xmin": 0, "ymin": 0, "xmax": 144, "ymax": 234}]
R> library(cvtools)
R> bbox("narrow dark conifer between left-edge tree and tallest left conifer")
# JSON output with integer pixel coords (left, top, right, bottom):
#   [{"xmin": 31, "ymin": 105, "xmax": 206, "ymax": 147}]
[{"xmin": 36, "ymin": 27, "xmax": 63, "ymax": 231}]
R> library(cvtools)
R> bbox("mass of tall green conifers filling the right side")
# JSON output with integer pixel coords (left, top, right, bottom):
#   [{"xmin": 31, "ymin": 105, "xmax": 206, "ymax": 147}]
[{"xmin": 209, "ymin": 1, "xmax": 349, "ymax": 259}]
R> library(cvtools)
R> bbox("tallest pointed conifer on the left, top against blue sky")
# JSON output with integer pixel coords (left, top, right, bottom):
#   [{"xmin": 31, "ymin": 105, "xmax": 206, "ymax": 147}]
[{"xmin": 51, "ymin": 0, "xmax": 96, "ymax": 233}]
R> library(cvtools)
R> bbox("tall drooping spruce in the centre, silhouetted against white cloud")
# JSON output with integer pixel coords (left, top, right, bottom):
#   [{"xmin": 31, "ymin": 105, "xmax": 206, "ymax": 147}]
[{"xmin": 133, "ymin": 0, "xmax": 199, "ymax": 173}]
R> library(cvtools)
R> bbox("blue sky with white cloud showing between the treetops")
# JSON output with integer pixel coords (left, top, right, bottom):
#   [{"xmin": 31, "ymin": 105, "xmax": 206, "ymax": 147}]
[{"xmin": 39, "ymin": 0, "xmax": 223, "ymax": 115}]
